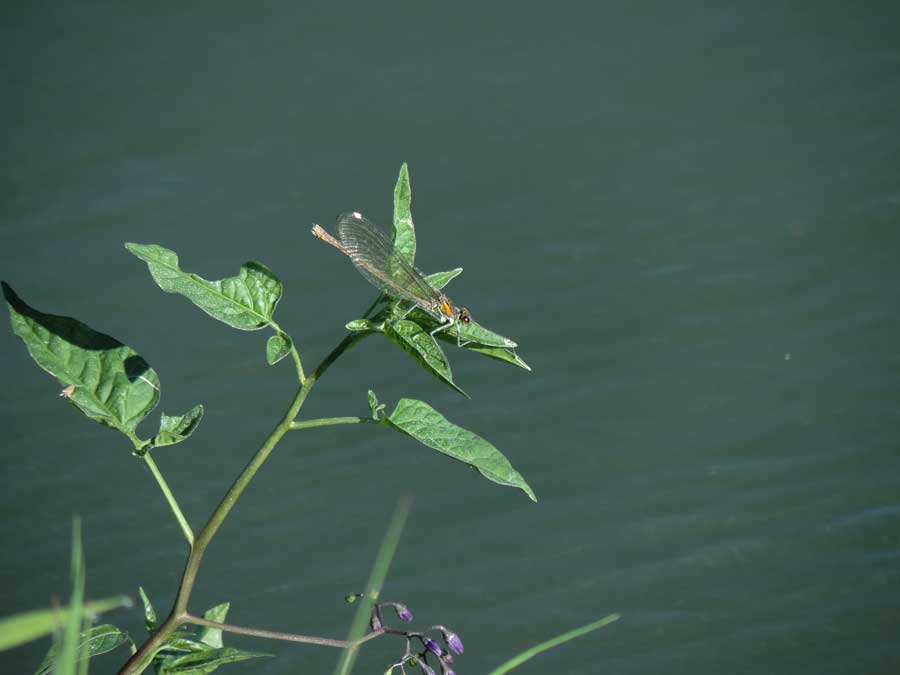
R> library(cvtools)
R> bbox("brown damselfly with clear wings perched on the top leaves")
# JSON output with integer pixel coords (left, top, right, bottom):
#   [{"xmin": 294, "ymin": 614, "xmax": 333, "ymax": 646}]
[{"xmin": 312, "ymin": 211, "xmax": 472, "ymax": 347}]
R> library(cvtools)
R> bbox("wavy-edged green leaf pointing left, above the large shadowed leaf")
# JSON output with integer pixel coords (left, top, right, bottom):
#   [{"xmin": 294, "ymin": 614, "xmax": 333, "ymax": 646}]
[{"xmin": 125, "ymin": 243, "xmax": 282, "ymax": 330}]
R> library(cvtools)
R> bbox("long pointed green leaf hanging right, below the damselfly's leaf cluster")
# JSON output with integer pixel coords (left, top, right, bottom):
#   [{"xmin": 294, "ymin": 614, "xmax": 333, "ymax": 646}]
[{"xmin": 385, "ymin": 398, "xmax": 537, "ymax": 502}]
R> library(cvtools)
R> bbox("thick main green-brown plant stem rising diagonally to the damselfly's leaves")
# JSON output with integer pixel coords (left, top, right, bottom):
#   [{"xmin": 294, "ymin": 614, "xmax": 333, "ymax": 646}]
[{"xmin": 119, "ymin": 333, "xmax": 365, "ymax": 675}]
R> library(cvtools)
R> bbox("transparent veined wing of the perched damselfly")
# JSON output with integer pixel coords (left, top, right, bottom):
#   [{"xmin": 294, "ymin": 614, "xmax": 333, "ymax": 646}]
[{"xmin": 337, "ymin": 212, "xmax": 440, "ymax": 307}]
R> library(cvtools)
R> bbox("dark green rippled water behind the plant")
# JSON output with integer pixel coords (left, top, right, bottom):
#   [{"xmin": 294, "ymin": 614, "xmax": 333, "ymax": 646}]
[{"xmin": 0, "ymin": 2, "xmax": 900, "ymax": 675}]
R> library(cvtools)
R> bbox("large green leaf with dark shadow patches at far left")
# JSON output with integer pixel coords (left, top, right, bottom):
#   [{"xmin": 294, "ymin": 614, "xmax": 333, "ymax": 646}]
[{"xmin": 3, "ymin": 282, "xmax": 159, "ymax": 447}]
